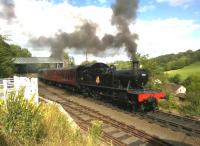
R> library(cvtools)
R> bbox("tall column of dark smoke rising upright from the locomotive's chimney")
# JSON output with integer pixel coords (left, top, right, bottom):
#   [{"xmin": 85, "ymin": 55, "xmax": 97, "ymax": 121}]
[{"xmin": 112, "ymin": 0, "xmax": 138, "ymax": 59}]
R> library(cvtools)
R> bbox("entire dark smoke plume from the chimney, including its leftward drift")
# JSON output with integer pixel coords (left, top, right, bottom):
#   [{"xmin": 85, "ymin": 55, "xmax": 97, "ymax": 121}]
[{"xmin": 30, "ymin": 0, "xmax": 138, "ymax": 59}]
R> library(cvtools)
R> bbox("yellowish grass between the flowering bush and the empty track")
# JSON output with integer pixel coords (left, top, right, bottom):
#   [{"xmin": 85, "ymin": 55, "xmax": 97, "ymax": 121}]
[{"xmin": 42, "ymin": 104, "xmax": 102, "ymax": 146}]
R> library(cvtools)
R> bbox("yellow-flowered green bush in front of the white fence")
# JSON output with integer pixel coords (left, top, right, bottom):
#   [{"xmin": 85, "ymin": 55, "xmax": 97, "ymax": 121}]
[{"xmin": 0, "ymin": 90, "xmax": 43, "ymax": 145}]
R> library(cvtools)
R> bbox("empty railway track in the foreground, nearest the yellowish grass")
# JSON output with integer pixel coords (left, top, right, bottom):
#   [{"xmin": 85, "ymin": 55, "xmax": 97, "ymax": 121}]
[{"xmin": 39, "ymin": 88, "xmax": 172, "ymax": 146}]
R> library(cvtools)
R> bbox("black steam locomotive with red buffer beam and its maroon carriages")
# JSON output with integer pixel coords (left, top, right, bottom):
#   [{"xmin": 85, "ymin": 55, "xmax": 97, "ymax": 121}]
[{"xmin": 38, "ymin": 61, "xmax": 166, "ymax": 111}]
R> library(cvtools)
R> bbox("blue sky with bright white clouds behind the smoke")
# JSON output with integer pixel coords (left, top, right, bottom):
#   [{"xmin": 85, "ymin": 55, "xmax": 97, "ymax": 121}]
[{"xmin": 0, "ymin": 0, "xmax": 200, "ymax": 64}]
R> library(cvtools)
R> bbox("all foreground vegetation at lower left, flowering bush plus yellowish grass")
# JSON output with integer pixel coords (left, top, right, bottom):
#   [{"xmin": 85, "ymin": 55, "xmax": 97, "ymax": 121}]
[{"xmin": 0, "ymin": 90, "xmax": 102, "ymax": 146}]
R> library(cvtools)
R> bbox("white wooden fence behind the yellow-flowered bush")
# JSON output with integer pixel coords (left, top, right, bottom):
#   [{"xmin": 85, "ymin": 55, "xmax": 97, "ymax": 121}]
[{"xmin": 0, "ymin": 76, "xmax": 38, "ymax": 103}]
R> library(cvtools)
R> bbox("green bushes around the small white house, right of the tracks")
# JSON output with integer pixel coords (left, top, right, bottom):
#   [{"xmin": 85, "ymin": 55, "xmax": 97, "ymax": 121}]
[{"xmin": 159, "ymin": 75, "xmax": 200, "ymax": 116}]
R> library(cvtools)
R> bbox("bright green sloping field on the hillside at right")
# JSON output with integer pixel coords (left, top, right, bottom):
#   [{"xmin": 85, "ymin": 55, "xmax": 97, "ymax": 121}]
[{"xmin": 166, "ymin": 62, "xmax": 200, "ymax": 79}]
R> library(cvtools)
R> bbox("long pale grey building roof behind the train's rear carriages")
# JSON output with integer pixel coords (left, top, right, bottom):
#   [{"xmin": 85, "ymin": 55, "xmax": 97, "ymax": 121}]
[{"xmin": 14, "ymin": 57, "xmax": 63, "ymax": 64}]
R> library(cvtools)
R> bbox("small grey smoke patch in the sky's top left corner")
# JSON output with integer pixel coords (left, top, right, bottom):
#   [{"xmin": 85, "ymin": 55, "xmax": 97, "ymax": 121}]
[{"xmin": 0, "ymin": 0, "xmax": 15, "ymax": 21}]
